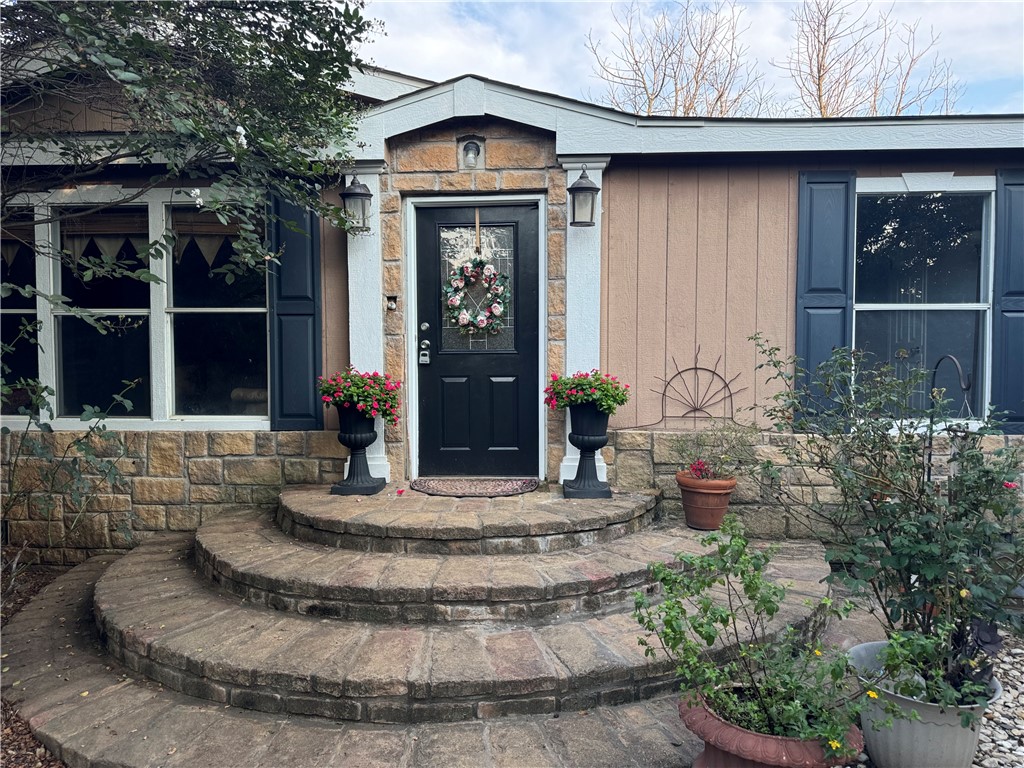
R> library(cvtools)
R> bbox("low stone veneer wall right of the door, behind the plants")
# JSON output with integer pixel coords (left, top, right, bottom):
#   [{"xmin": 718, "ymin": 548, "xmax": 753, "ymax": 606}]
[{"xmin": 603, "ymin": 429, "xmax": 1024, "ymax": 539}]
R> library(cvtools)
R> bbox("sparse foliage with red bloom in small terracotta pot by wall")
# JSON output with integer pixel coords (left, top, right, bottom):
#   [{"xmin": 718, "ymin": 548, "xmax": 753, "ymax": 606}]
[{"xmin": 672, "ymin": 419, "xmax": 761, "ymax": 479}]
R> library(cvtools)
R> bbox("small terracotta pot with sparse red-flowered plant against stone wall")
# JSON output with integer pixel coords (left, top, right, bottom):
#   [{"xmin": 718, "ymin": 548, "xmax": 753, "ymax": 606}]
[{"xmin": 673, "ymin": 419, "xmax": 760, "ymax": 530}]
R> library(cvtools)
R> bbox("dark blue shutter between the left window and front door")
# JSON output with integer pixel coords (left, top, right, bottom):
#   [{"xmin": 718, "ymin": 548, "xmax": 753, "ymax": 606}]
[{"xmin": 269, "ymin": 198, "xmax": 324, "ymax": 430}]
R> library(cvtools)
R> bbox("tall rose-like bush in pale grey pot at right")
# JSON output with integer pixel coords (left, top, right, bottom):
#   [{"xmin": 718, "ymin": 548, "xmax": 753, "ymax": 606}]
[{"xmin": 758, "ymin": 339, "xmax": 1024, "ymax": 768}]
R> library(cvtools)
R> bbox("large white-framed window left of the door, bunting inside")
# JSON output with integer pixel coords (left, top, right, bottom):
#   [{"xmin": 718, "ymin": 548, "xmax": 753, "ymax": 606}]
[{"xmin": 4, "ymin": 186, "xmax": 269, "ymax": 429}]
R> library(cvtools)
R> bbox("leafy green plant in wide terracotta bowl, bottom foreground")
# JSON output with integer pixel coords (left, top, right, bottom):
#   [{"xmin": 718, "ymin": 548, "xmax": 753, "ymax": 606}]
[{"xmin": 634, "ymin": 515, "xmax": 863, "ymax": 768}]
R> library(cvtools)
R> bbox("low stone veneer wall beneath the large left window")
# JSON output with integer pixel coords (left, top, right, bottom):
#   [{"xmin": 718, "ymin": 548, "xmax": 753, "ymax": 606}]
[{"xmin": 0, "ymin": 431, "xmax": 348, "ymax": 564}]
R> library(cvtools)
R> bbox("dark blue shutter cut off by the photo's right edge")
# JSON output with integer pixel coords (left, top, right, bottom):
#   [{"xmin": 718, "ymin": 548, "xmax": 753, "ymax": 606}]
[{"xmin": 992, "ymin": 169, "xmax": 1024, "ymax": 434}]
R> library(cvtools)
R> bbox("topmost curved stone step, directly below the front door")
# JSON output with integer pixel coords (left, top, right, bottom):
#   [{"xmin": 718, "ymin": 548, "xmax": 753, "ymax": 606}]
[{"xmin": 278, "ymin": 485, "xmax": 660, "ymax": 555}]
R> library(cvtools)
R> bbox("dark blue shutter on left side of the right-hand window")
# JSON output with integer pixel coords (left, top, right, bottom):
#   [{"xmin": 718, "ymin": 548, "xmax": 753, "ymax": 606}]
[{"xmin": 796, "ymin": 171, "xmax": 856, "ymax": 380}]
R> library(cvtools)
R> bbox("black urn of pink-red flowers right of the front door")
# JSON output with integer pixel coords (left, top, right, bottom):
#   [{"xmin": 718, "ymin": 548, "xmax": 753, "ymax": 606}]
[{"xmin": 544, "ymin": 369, "xmax": 630, "ymax": 499}]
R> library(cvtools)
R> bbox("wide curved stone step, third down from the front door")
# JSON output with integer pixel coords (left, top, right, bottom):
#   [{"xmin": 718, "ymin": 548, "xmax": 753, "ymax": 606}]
[{"xmin": 95, "ymin": 536, "xmax": 827, "ymax": 723}]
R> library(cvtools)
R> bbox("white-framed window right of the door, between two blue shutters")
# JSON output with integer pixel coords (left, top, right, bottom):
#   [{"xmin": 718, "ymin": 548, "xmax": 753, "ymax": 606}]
[{"xmin": 853, "ymin": 173, "xmax": 995, "ymax": 418}]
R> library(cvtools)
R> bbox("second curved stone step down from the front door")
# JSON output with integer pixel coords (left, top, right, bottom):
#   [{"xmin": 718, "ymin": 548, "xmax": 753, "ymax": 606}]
[{"xmin": 196, "ymin": 510, "xmax": 700, "ymax": 624}]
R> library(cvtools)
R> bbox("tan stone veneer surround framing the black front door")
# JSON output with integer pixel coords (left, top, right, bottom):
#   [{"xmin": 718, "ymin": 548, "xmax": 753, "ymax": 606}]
[{"xmin": 380, "ymin": 119, "xmax": 566, "ymax": 480}]
